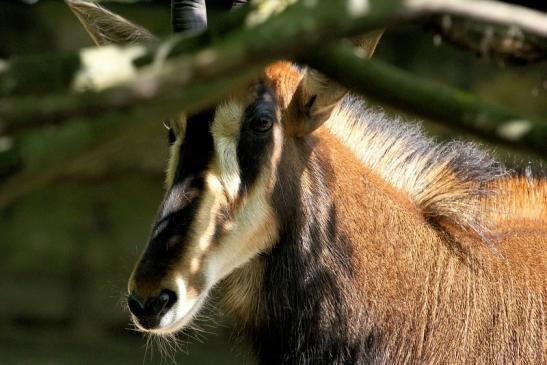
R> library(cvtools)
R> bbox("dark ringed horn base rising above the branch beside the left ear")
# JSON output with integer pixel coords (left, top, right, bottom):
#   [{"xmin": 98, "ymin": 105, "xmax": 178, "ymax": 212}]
[{"xmin": 171, "ymin": 0, "xmax": 207, "ymax": 33}]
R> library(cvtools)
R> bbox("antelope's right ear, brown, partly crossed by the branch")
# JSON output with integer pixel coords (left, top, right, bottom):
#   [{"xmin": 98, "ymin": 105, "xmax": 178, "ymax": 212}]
[{"xmin": 289, "ymin": 30, "xmax": 383, "ymax": 136}]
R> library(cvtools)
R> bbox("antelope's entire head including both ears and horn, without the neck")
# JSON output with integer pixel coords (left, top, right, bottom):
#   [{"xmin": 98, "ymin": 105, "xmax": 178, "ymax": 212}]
[{"xmin": 66, "ymin": 1, "xmax": 379, "ymax": 334}]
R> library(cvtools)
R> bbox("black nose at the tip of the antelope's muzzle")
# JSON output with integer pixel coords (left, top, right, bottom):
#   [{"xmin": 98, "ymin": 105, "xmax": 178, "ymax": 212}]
[{"xmin": 127, "ymin": 289, "xmax": 177, "ymax": 328}]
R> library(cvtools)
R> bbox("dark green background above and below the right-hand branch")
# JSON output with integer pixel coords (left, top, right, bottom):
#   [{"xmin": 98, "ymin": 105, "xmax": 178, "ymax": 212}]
[{"xmin": 375, "ymin": 26, "xmax": 547, "ymax": 166}]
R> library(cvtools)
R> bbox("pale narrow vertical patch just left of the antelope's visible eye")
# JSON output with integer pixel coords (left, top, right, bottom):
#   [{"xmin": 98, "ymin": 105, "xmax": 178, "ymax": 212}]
[{"xmin": 211, "ymin": 102, "xmax": 243, "ymax": 201}]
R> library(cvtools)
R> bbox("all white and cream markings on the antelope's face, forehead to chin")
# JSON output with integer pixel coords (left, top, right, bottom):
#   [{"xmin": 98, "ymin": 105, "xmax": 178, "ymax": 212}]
[{"xmin": 153, "ymin": 102, "xmax": 282, "ymax": 334}]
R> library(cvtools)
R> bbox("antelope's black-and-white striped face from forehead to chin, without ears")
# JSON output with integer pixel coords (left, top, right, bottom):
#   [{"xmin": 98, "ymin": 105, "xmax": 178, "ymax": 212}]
[{"xmin": 129, "ymin": 69, "xmax": 282, "ymax": 332}]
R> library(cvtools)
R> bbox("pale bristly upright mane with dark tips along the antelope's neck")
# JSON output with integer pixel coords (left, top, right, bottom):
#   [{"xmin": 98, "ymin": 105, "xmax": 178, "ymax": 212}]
[{"xmin": 327, "ymin": 95, "xmax": 507, "ymax": 238}]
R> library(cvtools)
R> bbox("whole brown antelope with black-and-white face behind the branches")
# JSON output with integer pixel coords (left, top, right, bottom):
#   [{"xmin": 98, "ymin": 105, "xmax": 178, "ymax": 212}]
[{"xmin": 66, "ymin": 1, "xmax": 547, "ymax": 364}]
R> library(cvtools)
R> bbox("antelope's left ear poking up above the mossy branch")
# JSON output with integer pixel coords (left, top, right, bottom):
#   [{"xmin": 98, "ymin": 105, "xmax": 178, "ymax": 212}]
[{"xmin": 65, "ymin": 0, "xmax": 154, "ymax": 46}]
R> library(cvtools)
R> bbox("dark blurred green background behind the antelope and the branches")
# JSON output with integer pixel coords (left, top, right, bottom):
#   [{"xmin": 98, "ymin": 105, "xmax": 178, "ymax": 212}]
[{"xmin": 0, "ymin": 0, "xmax": 547, "ymax": 364}]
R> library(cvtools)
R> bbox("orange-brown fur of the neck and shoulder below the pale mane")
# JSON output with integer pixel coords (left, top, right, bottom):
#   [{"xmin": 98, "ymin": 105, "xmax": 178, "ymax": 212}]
[{"xmin": 327, "ymin": 128, "xmax": 547, "ymax": 364}]
